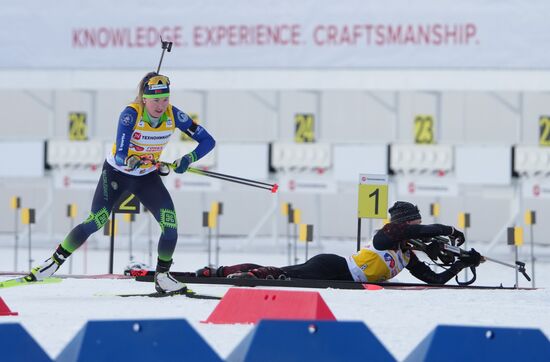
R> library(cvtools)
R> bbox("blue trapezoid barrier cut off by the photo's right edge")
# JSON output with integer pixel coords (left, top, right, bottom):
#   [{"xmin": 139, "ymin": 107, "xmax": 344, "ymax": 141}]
[{"xmin": 405, "ymin": 325, "xmax": 550, "ymax": 362}]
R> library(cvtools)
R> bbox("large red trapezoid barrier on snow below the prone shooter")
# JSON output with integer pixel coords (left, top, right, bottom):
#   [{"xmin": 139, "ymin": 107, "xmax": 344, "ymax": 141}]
[{"xmin": 205, "ymin": 288, "xmax": 336, "ymax": 324}]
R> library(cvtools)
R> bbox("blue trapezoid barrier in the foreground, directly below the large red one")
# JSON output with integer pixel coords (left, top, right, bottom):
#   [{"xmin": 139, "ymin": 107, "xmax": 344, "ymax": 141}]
[{"xmin": 226, "ymin": 320, "xmax": 395, "ymax": 362}]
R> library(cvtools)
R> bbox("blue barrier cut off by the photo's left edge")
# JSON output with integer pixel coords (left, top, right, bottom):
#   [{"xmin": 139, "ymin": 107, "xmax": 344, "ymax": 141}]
[{"xmin": 0, "ymin": 323, "xmax": 51, "ymax": 362}]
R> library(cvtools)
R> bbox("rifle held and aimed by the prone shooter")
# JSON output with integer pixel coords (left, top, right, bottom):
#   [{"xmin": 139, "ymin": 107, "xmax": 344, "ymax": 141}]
[{"xmin": 408, "ymin": 236, "xmax": 531, "ymax": 285}]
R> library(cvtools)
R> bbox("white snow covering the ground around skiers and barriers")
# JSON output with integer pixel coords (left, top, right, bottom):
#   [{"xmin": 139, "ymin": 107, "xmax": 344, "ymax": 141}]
[{"xmin": 0, "ymin": 242, "xmax": 550, "ymax": 360}]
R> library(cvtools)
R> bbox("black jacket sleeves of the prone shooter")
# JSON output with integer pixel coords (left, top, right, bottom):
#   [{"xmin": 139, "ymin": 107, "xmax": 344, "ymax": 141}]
[{"xmin": 373, "ymin": 223, "xmax": 467, "ymax": 284}]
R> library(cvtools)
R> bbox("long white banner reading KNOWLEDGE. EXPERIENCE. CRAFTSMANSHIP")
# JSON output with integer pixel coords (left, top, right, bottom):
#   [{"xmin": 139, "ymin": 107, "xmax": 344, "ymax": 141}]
[{"xmin": 0, "ymin": 0, "xmax": 550, "ymax": 69}]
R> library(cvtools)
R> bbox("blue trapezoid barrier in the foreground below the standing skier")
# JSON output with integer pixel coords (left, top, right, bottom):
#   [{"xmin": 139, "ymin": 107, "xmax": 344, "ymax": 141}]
[{"xmin": 56, "ymin": 319, "xmax": 221, "ymax": 362}]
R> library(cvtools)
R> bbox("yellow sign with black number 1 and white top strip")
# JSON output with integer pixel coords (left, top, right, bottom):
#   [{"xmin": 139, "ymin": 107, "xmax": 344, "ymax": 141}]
[{"xmin": 357, "ymin": 174, "xmax": 388, "ymax": 219}]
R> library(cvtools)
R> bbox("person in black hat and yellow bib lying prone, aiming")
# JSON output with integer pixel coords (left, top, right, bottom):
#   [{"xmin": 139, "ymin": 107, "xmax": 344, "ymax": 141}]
[{"xmin": 197, "ymin": 201, "xmax": 482, "ymax": 284}]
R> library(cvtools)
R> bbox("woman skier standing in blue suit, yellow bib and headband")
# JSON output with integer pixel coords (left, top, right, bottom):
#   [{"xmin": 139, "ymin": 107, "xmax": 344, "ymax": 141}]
[{"xmin": 26, "ymin": 72, "xmax": 215, "ymax": 293}]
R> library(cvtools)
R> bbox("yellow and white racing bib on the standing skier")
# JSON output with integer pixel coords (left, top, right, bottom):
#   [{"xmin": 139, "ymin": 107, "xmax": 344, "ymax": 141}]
[{"xmin": 107, "ymin": 103, "xmax": 176, "ymax": 176}]
